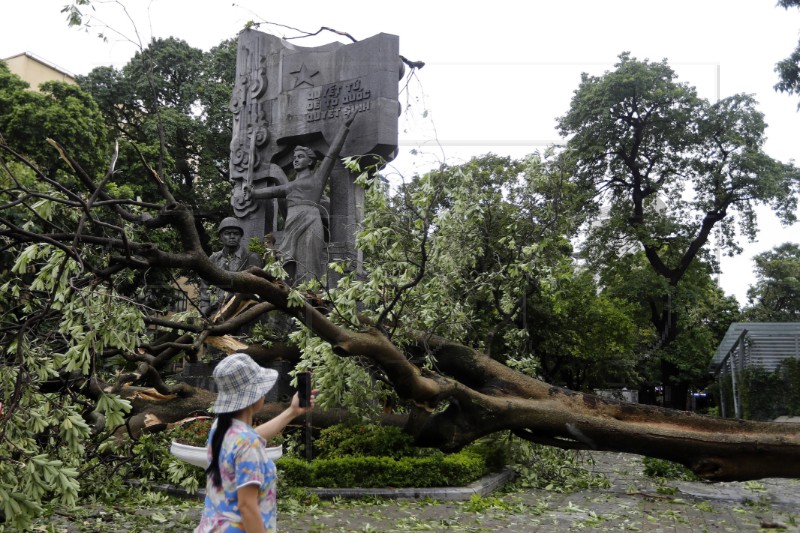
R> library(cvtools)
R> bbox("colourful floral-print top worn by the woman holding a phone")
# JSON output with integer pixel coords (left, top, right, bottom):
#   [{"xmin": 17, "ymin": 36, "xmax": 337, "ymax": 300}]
[{"xmin": 195, "ymin": 418, "xmax": 277, "ymax": 533}]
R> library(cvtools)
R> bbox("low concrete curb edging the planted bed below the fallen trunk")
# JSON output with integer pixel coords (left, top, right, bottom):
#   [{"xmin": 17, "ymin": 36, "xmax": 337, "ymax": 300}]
[{"xmin": 141, "ymin": 468, "xmax": 514, "ymax": 502}]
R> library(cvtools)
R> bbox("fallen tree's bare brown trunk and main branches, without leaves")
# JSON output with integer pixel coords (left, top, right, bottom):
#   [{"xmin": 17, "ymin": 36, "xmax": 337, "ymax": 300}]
[{"xmin": 3, "ymin": 178, "xmax": 800, "ymax": 480}]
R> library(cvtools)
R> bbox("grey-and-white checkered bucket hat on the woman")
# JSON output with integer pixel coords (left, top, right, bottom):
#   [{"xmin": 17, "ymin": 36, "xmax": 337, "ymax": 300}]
[{"xmin": 213, "ymin": 353, "xmax": 278, "ymax": 414}]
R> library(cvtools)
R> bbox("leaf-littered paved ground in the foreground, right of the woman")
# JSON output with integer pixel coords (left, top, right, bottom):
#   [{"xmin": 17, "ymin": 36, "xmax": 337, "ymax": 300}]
[{"xmin": 279, "ymin": 453, "xmax": 800, "ymax": 533}]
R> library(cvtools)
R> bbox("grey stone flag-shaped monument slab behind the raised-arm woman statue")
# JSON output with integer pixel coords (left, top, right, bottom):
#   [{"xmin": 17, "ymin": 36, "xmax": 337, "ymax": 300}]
[{"xmin": 230, "ymin": 29, "xmax": 403, "ymax": 285}]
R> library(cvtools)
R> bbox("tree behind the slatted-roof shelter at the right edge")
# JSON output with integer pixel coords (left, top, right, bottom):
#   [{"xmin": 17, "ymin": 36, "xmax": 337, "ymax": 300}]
[{"xmin": 744, "ymin": 242, "xmax": 800, "ymax": 322}]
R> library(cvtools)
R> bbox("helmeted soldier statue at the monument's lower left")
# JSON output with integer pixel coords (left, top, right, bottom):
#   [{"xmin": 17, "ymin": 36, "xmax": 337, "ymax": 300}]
[{"xmin": 200, "ymin": 217, "xmax": 264, "ymax": 317}]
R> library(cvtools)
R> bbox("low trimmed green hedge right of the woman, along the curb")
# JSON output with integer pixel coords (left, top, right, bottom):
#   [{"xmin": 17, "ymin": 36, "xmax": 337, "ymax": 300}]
[{"xmin": 277, "ymin": 451, "xmax": 488, "ymax": 488}]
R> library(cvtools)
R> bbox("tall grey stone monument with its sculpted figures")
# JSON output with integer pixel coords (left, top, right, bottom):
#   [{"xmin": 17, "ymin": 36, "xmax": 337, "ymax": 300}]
[{"xmin": 188, "ymin": 29, "xmax": 404, "ymax": 390}]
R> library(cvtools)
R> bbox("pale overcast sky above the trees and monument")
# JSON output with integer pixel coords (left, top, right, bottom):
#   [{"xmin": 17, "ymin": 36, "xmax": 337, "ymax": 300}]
[{"xmin": 0, "ymin": 0, "xmax": 800, "ymax": 304}]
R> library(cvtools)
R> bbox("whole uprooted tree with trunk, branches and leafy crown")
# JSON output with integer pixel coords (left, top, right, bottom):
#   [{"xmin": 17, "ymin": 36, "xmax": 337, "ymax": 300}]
[{"xmin": 0, "ymin": 130, "xmax": 800, "ymax": 486}]
